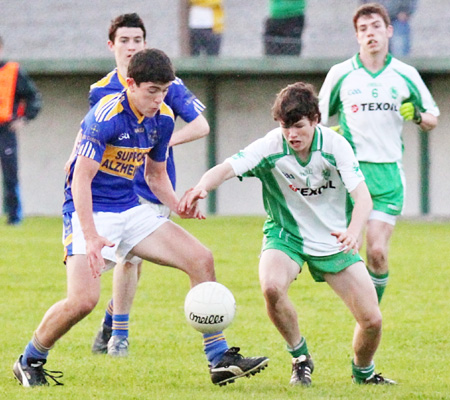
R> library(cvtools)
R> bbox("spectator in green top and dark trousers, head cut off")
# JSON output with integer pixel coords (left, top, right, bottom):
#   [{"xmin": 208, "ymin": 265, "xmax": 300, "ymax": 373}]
[{"xmin": 264, "ymin": 0, "xmax": 306, "ymax": 56}]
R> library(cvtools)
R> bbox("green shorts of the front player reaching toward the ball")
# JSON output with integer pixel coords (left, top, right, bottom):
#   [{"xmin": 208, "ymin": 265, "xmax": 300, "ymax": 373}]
[{"xmin": 262, "ymin": 234, "xmax": 362, "ymax": 282}]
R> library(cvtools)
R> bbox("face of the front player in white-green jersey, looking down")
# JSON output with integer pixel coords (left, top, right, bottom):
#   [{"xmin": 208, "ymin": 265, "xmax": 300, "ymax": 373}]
[{"xmin": 280, "ymin": 117, "xmax": 317, "ymax": 159}]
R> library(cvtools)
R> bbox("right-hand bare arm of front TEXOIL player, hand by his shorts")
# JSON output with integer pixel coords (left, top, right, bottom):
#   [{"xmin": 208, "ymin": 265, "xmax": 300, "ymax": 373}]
[{"xmin": 331, "ymin": 182, "xmax": 372, "ymax": 254}]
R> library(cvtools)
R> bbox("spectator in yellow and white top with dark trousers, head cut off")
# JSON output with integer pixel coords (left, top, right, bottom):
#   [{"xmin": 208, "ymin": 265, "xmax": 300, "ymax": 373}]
[{"xmin": 189, "ymin": 0, "xmax": 224, "ymax": 56}]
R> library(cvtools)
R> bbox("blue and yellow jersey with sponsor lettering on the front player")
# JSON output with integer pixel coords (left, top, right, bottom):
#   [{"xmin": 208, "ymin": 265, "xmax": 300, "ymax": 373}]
[{"xmin": 63, "ymin": 90, "xmax": 173, "ymax": 212}]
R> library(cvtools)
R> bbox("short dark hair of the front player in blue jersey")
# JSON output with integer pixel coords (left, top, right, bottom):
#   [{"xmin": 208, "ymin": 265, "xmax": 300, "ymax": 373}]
[{"xmin": 127, "ymin": 49, "xmax": 175, "ymax": 86}]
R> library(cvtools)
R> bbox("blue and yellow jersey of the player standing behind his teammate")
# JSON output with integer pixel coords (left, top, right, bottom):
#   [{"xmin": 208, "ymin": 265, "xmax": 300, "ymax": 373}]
[{"xmin": 89, "ymin": 68, "xmax": 205, "ymax": 204}]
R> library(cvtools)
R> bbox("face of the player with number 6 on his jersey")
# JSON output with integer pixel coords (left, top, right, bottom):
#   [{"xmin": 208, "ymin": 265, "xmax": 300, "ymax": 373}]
[{"xmin": 356, "ymin": 14, "xmax": 393, "ymax": 54}]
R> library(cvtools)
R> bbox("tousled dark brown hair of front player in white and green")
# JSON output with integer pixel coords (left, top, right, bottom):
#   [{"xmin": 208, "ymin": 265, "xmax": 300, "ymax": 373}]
[{"xmin": 272, "ymin": 82, "xmax": 320, "ymax": 128}]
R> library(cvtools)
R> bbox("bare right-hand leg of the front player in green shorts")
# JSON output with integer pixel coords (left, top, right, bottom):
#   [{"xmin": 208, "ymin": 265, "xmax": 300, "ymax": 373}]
[{"xmin": 325, "ymin": 262, "xmax": 382, "ymax": 367}]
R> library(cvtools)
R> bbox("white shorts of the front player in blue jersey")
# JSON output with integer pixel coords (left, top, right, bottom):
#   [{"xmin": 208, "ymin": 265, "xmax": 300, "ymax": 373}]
[{"xmin": 63, "ymin": 204, "xmax": 168, "ymax": 270}]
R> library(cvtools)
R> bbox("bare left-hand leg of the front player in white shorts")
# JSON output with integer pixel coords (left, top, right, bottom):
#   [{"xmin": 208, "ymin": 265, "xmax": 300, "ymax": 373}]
[{"xmin": 36, "ymin": 255, "xmax": 100, "ymax": 348}]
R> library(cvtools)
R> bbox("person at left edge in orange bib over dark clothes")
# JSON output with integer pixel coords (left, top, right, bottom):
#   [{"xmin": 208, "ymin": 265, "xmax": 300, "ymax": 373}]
[{"xmin": 0, "ymin": 37, "xmax": 41, "ymax": 225}]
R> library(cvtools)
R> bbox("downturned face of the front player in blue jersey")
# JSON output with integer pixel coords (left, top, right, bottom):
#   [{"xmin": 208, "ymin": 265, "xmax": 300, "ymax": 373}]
[{"xmin": 127, "ymin": 78, "xmax": 172, "ymax": 118}]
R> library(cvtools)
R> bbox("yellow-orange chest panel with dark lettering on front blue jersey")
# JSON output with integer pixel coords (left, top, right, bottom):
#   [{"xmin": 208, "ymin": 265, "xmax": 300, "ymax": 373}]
[{"xmin": 100, "ymin": 145, "xmax": 151, "ymax": 180}]
